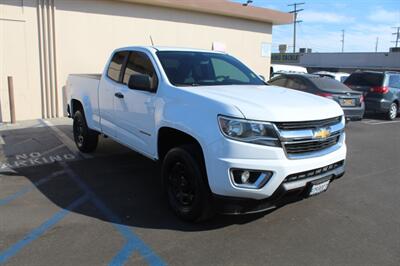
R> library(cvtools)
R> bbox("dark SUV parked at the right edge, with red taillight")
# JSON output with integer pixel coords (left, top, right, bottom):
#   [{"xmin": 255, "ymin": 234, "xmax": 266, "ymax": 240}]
[{"xmin": 345, "ymin": 71, "xmax": 400, "ymax": 120}]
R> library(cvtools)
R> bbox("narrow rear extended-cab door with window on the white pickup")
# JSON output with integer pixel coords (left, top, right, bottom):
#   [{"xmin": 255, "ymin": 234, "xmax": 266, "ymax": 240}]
[{"xmin": 99, "ymin": 51, "xmax": 129, "ymax": 137}]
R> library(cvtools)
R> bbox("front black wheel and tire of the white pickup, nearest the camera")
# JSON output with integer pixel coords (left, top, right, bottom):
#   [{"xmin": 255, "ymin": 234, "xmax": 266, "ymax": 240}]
[{"xmin": 162, "ymin": 145, "xmax": 214, "ymax": 222}]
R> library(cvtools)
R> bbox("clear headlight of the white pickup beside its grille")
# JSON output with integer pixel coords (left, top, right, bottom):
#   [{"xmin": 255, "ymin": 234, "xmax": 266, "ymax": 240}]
[{"xmin": 218, "ymin": 116, "xmax": 281, "ymax": 147}]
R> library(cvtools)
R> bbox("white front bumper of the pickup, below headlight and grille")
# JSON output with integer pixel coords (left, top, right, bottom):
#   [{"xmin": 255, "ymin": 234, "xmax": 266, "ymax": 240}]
[{"xmin": 204, "ymin": 133, "xmax": 347, "ymax": 200}]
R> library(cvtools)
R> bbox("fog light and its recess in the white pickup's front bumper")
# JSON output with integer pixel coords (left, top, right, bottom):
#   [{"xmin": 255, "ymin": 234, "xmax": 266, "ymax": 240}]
[{"xmin": 231, "ymin": 169, "xmax": 273, "ymax": 189}]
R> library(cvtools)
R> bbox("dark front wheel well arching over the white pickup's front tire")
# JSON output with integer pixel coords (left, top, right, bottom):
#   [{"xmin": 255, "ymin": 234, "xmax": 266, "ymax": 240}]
[{"xmin": 157, "ymin": 127, "xmax": 204, "ymax": 161}]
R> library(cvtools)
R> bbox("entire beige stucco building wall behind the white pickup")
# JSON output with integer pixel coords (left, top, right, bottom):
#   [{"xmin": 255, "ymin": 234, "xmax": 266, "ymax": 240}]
[{"xmin": 0, "ymin": 0, "xmax": 272, "ymax": 121}]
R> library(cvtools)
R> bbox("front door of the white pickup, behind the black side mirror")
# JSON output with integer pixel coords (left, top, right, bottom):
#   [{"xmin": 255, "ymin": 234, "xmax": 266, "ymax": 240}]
[{"xmin": 115, "ymin": 51, "xmax": 158, "ymax": 157}]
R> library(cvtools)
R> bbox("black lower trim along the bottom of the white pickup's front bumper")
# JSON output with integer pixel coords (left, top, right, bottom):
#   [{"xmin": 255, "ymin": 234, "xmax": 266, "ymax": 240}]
[{"xmin": 213, "ymin": 169, "xmax": 345, "ymax": 215}]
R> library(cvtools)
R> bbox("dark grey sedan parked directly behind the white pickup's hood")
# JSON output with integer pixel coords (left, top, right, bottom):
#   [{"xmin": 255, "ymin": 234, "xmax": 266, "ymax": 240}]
[{"xmin": 268, "ymin": 74, "xmax": 365, "ymax": 120}]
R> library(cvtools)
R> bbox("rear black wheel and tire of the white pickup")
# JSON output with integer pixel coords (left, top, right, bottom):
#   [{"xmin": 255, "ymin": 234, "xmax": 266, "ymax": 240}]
[{"xmin": 73, "ymin": 111, "xmax": 99, "ymax": 153}]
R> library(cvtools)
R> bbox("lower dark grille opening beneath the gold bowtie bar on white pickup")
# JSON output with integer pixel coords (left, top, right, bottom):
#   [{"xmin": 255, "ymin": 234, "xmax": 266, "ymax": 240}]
[{"xmin": 284, "ymin": 135, "xmax": 340, "ymax": 155}]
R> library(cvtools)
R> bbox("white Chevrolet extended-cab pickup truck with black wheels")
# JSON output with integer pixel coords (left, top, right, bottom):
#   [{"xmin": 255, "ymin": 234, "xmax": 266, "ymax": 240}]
[{"xmin": 66, "ymin": 47, "xmax": 346, "ymax": 221}]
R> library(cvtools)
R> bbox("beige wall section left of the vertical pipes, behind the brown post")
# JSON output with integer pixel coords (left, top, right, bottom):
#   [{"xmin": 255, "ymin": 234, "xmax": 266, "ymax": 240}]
[{"xmin": 0, "ymin": 0, "xmax": 41, "ymax": 121}]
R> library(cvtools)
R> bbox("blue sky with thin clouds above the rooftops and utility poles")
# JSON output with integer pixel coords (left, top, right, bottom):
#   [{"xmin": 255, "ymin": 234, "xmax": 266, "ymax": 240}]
[{"xmin": 233, "ymin": 0, "xmax": 400, "ymax": 52}]
